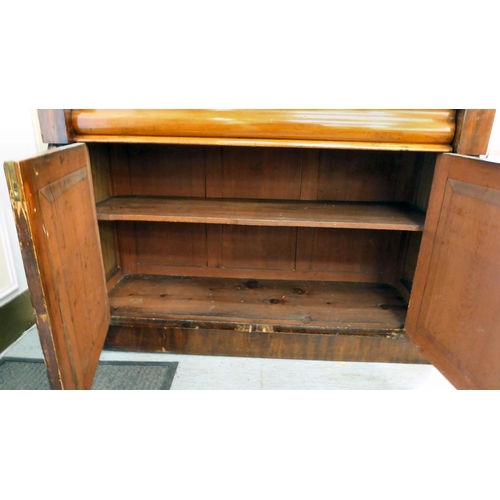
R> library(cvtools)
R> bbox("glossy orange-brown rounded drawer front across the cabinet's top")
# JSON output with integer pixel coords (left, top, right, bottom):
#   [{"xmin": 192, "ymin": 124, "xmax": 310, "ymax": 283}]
[{"xmin": 72, "ymin": 109, "xmax": 455, "ymax": 145}]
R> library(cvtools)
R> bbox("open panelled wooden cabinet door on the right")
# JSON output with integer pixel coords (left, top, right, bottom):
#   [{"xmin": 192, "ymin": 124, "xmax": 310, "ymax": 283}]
[{"xmin": 406, "ymin": 154, "xmax": 500, "ymax": 389}]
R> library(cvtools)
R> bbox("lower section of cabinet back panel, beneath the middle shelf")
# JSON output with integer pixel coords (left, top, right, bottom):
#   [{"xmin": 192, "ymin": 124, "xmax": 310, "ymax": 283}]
[{"xmin": 117, "ymin": 222, "xmax": 401, "ymax": 281}]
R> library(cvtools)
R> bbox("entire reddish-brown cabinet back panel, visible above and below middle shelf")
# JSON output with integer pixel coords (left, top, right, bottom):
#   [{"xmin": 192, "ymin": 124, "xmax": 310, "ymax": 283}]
[{"xmin": 106, "ymin": 144, "xmax": 428, "ymax": 281}]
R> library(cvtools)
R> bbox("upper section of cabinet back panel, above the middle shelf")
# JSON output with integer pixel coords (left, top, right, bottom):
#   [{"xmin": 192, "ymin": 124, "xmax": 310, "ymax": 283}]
[{"xmin": 109, "ymin": 144, "xmax": 423, "ymax": 202}]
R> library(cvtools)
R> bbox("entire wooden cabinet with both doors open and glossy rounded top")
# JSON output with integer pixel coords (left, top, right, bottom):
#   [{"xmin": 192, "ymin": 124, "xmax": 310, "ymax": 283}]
[{"xmin": 6, "ymin": 110, "xmax": 500, "ymax": 388}]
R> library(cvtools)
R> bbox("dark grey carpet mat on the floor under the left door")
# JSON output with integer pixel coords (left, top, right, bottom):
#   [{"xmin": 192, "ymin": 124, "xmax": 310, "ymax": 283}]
[{"xmin": 0, "ymin": 357, "xmax": 179, "ymax": 391}]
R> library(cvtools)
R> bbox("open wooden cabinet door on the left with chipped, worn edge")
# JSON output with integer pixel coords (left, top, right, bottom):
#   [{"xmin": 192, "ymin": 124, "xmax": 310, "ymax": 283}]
[{"xmin": 5, "ymin": 144, "xmax": 109, "ymax": 389}]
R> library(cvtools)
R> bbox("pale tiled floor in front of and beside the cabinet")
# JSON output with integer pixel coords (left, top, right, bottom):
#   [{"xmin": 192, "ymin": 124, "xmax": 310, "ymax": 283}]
[{"xmin": 2, "ymin": 327, "xmax": 454, "ymax": 391}]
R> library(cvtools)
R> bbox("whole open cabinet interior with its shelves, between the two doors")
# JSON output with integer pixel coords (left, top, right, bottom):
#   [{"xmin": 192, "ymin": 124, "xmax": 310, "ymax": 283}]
[{"xmin": 88, "ymin": 143, "xmax": 436, "ymax": 360}]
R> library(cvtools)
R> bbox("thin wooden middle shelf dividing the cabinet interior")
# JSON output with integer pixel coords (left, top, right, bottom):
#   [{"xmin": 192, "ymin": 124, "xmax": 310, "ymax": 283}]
[{"xmin": 97, "ymin": 196, "xmax": 425, "ymax": 231}]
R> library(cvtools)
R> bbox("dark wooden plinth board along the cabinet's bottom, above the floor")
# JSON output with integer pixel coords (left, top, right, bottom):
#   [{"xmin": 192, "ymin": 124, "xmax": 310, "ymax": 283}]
[{"xmin": 104, "ymin": 325, "xmax": 428, "ymax": 364}]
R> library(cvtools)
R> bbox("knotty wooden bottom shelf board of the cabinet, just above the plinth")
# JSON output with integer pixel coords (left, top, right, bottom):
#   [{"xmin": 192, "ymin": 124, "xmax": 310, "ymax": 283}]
[{"xmin": 109, "ymin": 275, "xmax": 407, "ymax": 334}]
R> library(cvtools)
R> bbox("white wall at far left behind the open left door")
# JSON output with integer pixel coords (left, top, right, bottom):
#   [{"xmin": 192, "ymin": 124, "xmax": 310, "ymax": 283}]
[{"xmin": 0, "ymin": 108, "xmax": 46, "ymax": 307}]
